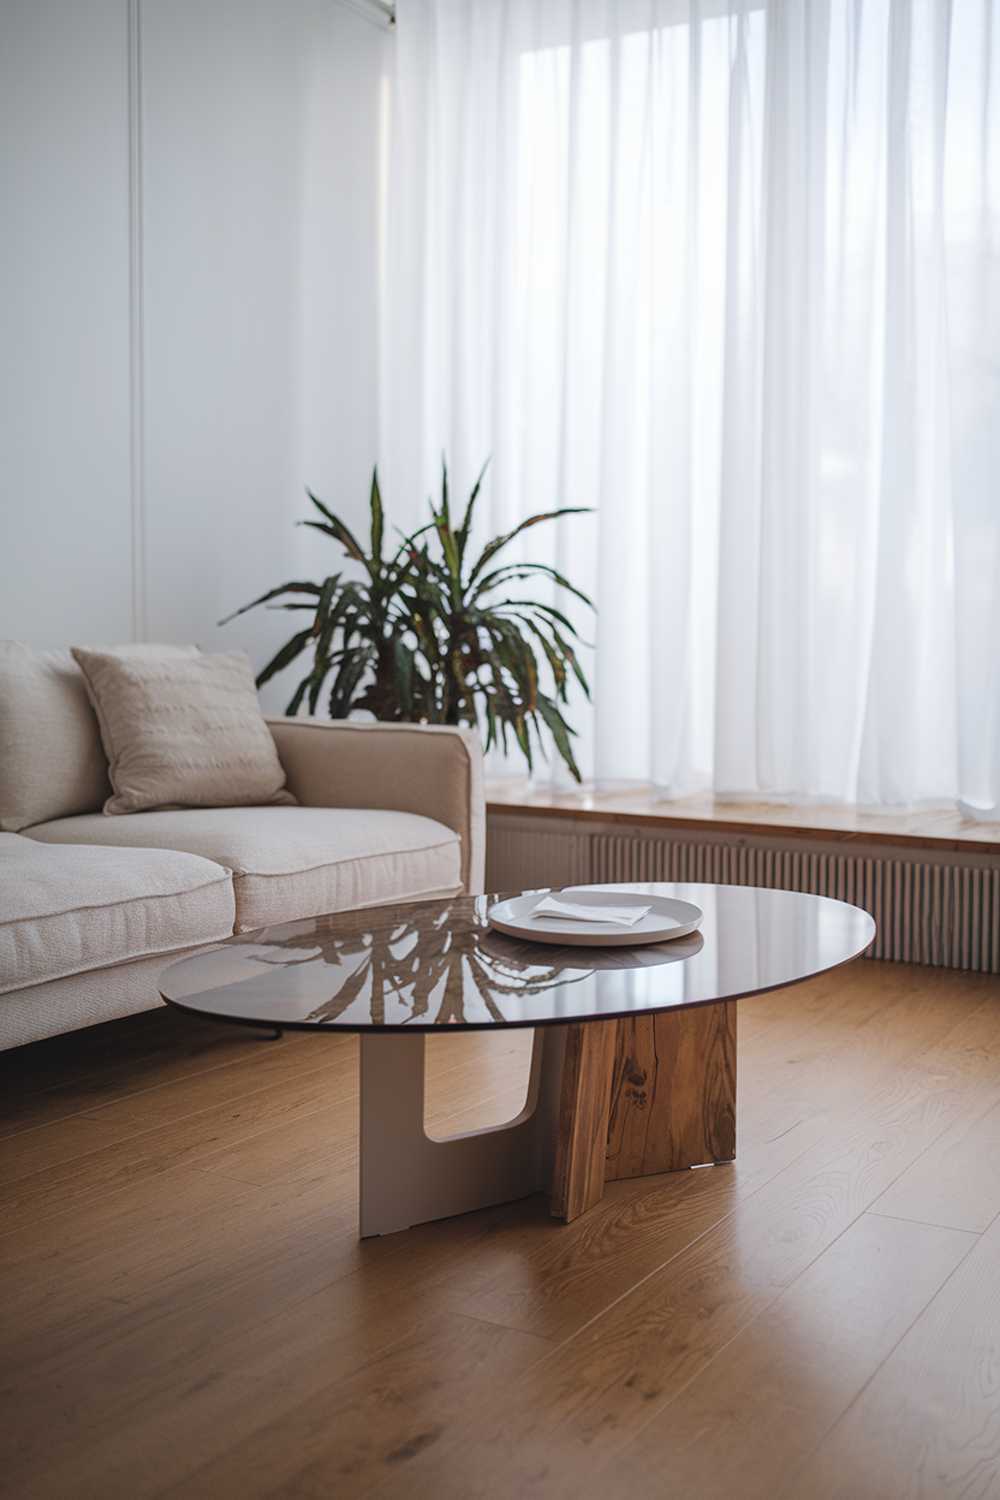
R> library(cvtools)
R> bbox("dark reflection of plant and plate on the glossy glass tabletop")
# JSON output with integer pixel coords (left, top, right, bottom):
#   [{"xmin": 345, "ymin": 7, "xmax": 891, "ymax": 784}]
[{"xmin": 227, "ymin": 899, "xmax": 702, "ymax": 1026}]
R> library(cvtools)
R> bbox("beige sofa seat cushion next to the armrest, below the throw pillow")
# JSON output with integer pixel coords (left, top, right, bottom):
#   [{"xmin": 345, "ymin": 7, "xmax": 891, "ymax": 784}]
[{"xmin": 27, "ymin": 807, "xmax": 462, "ymax": 932}]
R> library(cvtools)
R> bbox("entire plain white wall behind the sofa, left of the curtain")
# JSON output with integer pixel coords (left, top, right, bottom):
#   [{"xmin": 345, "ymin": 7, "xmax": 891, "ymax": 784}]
[{"xmin": 0, "ymin": 0, "xmax": 391, "ymax": 704}]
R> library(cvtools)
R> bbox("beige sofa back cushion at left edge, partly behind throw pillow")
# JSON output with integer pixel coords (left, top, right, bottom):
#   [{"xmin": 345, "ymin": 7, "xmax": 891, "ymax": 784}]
[{"xmin": 0, "ymin": 641, "xmax": 198, "ymax": 833}]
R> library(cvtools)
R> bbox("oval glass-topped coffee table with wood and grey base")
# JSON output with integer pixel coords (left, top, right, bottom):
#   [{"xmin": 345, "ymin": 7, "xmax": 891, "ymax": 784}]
[{"xmin": 160, "ymin": 882, "xmax": 876, "ymax": 1236}]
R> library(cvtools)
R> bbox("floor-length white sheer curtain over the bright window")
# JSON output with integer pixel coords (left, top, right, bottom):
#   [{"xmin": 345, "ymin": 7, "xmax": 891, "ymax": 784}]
[{"xmin": 382, "ymin": 0, "xmax": 1000, "ymax": 815}]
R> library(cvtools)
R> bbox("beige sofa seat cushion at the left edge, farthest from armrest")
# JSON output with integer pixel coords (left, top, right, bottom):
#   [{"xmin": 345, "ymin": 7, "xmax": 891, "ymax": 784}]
[{"xmin": 0, "ymin": 819, "xmax": 235, "ymax": 993}]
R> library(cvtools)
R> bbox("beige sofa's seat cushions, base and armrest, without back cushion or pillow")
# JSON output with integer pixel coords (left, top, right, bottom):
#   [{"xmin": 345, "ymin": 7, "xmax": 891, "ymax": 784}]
[{"xmin": 0, "ymin": 719, "xmax": 484, "ymax": 1050}]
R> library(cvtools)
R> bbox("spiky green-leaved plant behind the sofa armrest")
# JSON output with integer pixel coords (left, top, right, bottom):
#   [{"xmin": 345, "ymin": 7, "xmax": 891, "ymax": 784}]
[{"xmin": 220, "ymin": 465, "xmax": 594, "ymax": 782}]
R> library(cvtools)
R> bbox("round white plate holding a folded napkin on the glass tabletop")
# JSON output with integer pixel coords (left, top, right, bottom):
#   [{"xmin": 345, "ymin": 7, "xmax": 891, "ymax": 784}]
[{"xmin": 489, "ymin": 885, "xmax": 702, "ymax": 948}]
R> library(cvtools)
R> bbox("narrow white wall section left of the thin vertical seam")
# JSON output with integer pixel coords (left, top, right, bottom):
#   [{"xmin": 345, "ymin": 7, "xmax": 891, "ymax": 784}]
[{"xmin": 0, "ymin": 0, "xmax": 132, "ymax": 642}]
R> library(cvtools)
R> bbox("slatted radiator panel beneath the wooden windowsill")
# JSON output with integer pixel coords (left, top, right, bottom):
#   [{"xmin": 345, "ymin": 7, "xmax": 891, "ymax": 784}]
[{"xmin": 487, "ymin": 815, "xmax": 1000, "ymax": 974}]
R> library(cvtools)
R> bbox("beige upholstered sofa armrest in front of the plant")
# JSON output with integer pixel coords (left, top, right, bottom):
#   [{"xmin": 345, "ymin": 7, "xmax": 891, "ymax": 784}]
[{"xmin": 267, "ymin": 719, "xmax": 486, "ymax": 896}]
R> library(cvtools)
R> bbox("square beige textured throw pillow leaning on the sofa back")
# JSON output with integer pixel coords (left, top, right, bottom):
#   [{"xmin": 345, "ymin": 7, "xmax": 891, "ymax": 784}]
[{"xmin": 73, "ymin": 650, "xmax": 295, "ymax": 813}]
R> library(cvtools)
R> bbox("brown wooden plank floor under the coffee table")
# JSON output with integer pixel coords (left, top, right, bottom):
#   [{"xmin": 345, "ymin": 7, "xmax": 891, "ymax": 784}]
[{"xmin": 0, "ymin": 962, "xmax": 1000, "ymax": 1500}]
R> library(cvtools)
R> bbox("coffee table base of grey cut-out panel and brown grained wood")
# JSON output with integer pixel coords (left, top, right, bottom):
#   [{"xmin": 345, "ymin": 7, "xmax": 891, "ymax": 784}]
[{"xmin": 360, "ymin": 1001, "xmax": 736, "ymax": 1236}]
